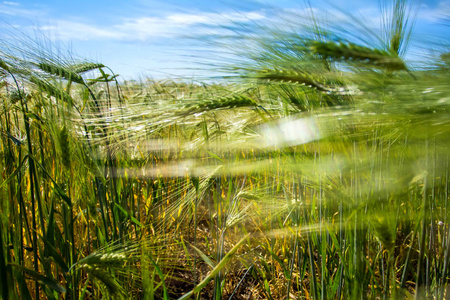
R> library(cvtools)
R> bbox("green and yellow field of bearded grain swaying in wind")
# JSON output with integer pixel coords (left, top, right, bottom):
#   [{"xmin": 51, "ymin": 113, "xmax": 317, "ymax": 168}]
[{"xmin": 0, "ymin": 0, "xmax": 450, "ymax": 299}]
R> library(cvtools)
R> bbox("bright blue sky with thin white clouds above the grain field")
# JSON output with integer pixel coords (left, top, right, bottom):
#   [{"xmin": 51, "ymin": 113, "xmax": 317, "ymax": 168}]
[{"xmin": 0, "ymin": 0, "xmax": 450, "ymax": 79}]
